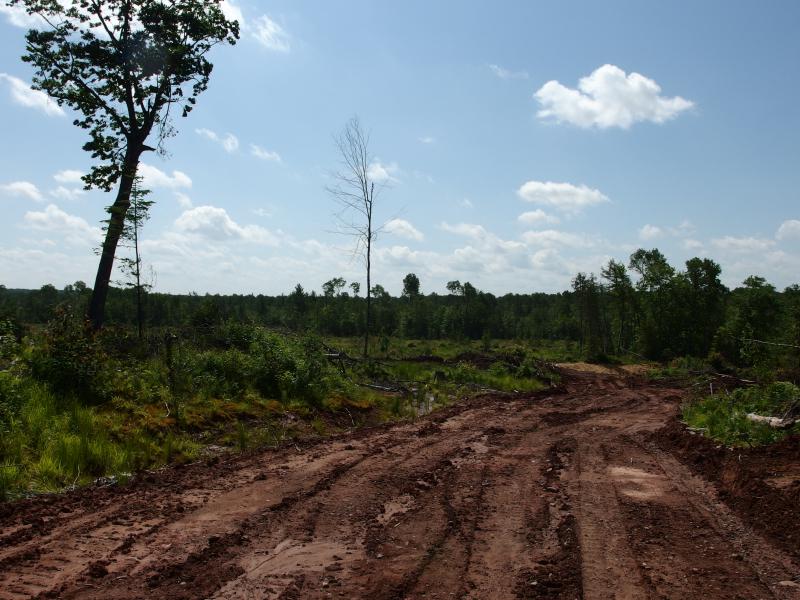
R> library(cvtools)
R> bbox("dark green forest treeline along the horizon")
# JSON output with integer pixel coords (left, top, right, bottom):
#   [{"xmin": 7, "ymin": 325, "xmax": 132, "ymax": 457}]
[{"xmin": 0, "ymin": 249, "xmax": 800, "ymax": 366}]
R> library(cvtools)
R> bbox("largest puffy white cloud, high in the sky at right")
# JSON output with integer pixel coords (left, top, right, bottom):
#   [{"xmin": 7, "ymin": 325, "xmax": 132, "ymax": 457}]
[{"xmin": 534, "ymin": 65, "xmax": 694, "ymax": 129}]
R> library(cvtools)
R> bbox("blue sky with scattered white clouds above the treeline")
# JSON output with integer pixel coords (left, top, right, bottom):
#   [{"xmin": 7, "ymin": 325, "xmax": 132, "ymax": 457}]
[{"xmin": 0, "ymin": 0, "xmax": 800, "ymax": 294}]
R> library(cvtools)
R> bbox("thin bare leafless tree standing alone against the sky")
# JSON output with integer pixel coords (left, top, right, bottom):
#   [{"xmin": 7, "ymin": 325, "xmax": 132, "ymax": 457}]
[{"xmin": 327, "ymin": 117, "xmax": 382, "ymax": 358}]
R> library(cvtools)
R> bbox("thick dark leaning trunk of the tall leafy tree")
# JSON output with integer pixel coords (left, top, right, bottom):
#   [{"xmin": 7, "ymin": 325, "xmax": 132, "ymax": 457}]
[{"xmin": 89, "ymin": 149, "xmax": 141, "ymax": 330}]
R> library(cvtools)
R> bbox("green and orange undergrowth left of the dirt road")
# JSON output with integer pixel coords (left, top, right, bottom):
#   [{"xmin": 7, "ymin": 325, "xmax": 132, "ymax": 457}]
[{"xmin": 0, "ymin": 309, "xmax": 555, "ymax": 501}]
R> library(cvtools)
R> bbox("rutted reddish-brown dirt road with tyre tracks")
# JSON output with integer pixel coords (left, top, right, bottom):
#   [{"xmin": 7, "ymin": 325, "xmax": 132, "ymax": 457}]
[{"xmin": 0, "ymin": 373, "xmax": 800, "ymax": 600}]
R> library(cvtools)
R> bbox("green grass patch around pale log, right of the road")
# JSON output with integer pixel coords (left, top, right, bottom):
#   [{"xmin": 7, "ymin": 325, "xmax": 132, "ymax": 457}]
[{"xmin": 683, "ymin": 382, "xmax": 800, "ymax": 446}]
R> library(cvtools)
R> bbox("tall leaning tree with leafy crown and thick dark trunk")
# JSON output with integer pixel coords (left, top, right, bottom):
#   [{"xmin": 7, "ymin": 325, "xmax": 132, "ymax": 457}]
[{"xmin": 8, "ymin": 0, "xmax": 239, "ymax": 328}]
